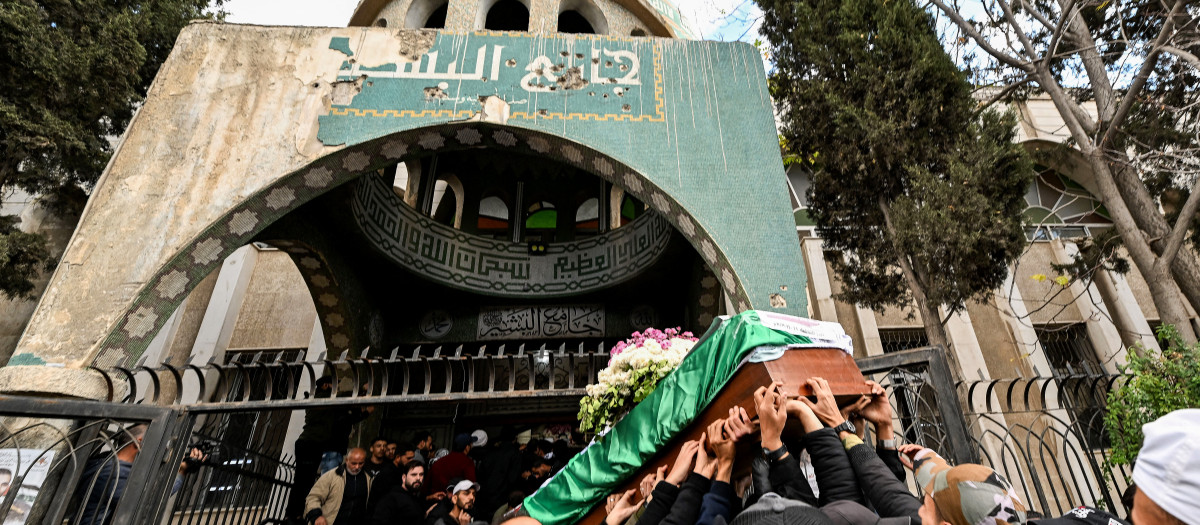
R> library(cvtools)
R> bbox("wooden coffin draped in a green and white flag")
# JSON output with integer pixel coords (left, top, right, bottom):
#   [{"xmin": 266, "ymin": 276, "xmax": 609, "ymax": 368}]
[{"xmin": 516, "ymin": 310, "xmax": 868, "ymax": 525}]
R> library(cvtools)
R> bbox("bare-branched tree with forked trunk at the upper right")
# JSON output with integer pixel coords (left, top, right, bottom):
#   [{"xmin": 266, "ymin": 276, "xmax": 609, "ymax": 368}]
[{"xmin": 930, "ymin": 0, "xmax": 1200, "ymax": 342}]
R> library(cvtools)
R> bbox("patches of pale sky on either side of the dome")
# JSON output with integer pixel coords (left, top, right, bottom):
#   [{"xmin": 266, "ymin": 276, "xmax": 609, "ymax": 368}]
[{"xmin": 224, "ymin": 0, "xmax": 760, "ymax": 42}]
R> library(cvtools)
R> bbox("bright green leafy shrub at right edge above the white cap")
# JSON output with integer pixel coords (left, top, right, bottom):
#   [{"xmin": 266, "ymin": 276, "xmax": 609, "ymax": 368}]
[{"xmin": 1104, "ymin": 325, "xmax": 1200, "ymax": 465}]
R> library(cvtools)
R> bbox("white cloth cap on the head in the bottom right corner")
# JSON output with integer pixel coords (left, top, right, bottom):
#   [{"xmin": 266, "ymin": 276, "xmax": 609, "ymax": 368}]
[{"xmin": 1133, "ymin": 409, "xmax": 1200, "ymax": 525}]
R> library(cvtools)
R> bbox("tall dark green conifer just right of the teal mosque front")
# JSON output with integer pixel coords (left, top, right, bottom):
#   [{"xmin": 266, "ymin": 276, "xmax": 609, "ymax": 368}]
[{"xmin": 757, "ymin": 0, "xmax": 1033, "ymax": 344}]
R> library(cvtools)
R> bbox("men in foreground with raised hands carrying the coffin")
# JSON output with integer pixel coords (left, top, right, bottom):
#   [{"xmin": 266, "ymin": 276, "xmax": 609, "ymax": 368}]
[{"xmin": 576, "ymin": 378, "xmax": 1200, "ymax": 525}]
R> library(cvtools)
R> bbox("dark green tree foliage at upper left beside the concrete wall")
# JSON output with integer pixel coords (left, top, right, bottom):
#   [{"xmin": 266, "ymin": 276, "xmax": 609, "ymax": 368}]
[{"xmin": 0, "ymin": 0, "xmax": 222, "ymax": 297}]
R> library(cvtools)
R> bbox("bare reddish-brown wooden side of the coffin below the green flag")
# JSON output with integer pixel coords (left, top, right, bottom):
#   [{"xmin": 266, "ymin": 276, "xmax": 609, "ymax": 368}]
[{"xmin": 578, "ymin": 349, "xmax": 870, "ymax": 525}]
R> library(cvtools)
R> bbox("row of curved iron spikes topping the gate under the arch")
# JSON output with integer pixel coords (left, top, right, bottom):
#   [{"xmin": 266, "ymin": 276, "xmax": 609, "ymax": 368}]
[{"xmin": 92, "ymin": 343, "xmax": 608, "ymax": 411}]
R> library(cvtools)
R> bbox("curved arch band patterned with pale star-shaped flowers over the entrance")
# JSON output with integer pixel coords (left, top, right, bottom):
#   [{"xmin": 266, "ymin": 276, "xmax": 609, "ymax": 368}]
[{"xmin": 92, "ymin": 122, "xmax": 751, "ymax": 368}]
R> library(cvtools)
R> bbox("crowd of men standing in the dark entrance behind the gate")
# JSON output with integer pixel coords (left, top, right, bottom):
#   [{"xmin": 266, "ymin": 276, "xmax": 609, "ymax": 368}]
[{"xmin": 293, "ymin": 429, "xmax": 570, "ymax": 525}]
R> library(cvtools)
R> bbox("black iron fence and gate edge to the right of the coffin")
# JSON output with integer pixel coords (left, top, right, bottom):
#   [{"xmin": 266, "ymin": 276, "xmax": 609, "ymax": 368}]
[{"xmin": 858, "ymin": 348, "xmax": 1132, "ymax": 517}]
